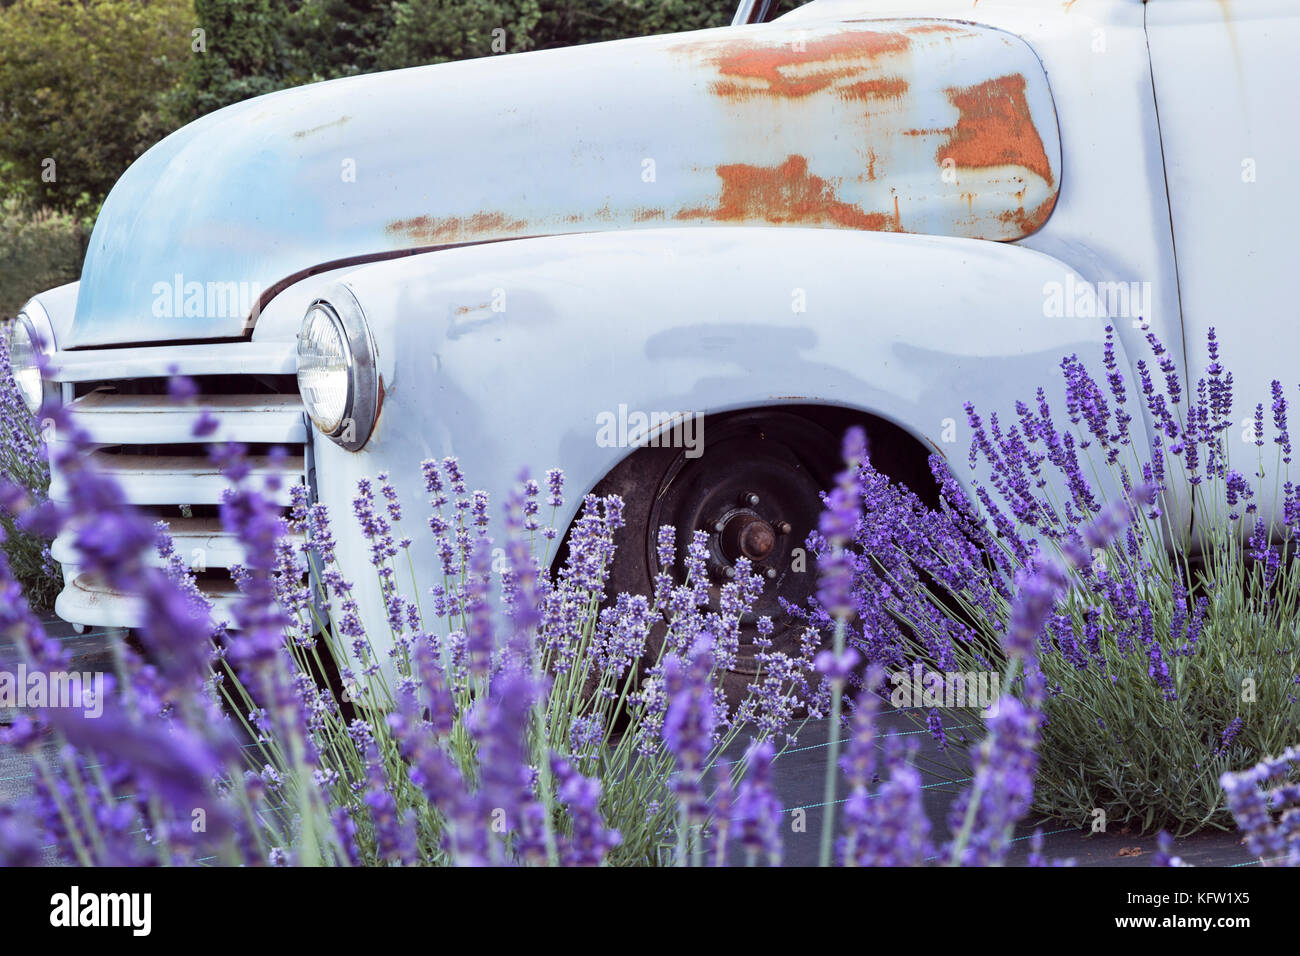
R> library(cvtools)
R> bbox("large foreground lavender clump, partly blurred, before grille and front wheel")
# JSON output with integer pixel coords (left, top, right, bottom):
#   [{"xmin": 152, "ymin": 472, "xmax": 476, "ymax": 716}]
[{"xmin": 0, "ymin": 381, "xmax": 1123, "ymax": 865}]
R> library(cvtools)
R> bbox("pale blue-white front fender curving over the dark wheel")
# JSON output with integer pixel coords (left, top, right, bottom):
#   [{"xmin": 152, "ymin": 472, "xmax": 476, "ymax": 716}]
[{"xmin": 315, "ymin": 228, "xmax": 1147, "ymax": 665}]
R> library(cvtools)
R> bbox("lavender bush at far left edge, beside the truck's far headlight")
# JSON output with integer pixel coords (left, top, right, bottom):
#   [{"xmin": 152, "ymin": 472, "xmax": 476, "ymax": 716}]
[{"xmin": 0, "ymin": 326, "xmax": 62, "ymax": 609}]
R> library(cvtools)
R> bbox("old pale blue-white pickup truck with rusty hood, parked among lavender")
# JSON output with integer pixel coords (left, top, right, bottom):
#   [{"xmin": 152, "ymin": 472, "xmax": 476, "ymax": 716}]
[{"xmin": 13, "ymin": 0, "xmax": 1300, "ymax": 679}]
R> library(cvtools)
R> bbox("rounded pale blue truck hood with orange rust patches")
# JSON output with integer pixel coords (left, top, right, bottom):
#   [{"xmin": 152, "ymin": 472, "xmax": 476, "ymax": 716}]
[{"xmin": 68, "ymin": 20, "xmax": 1061, "ymax": 347}]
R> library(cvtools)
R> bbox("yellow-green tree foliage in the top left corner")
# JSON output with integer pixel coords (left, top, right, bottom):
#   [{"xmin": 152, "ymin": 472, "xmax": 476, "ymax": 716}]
[{"xmin": 0, "ymin": 0, "xmax": 194, "ymax": 212}]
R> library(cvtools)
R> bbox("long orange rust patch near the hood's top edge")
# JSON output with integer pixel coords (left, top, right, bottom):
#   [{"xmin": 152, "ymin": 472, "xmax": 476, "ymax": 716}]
[{"xmin": 711, "ymin": 30, "xmax": 911, "ymax": 99}]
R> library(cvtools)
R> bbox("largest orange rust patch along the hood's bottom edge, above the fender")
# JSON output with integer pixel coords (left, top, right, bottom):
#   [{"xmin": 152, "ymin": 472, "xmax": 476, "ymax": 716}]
[{"xmin": 676, "ymin": 155, "xmax": 897, "ymax": 232}]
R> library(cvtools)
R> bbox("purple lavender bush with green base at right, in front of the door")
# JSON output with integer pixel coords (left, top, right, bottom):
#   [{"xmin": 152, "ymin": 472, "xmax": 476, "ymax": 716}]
[{"xmin": 809, "ymin": 329, "xmax": 1300, "ymax": 832}]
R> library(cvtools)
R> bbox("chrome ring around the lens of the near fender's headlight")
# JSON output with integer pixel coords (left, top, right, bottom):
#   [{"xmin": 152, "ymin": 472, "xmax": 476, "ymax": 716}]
[{"xmin": 298, "ymin": 286, "xmax": 380, "ymax": 451}]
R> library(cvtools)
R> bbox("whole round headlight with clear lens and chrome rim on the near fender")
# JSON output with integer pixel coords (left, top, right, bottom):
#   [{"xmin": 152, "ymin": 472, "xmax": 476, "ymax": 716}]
[{"xmin": 298, "ymin": 286, "xmax": 380, "ymax": 451}]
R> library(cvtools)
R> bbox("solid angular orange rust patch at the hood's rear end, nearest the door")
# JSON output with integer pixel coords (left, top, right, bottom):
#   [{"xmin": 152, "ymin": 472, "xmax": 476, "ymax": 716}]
[{"xmin": 935, "ymin": 73, "xmax": 1054, "ymax": 186}]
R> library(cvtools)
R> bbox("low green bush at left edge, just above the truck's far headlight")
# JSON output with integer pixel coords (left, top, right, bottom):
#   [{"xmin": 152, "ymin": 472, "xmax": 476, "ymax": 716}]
[{"xmin": 0, "ymin": 196, "xmax": 91, "ymax": 317}]
